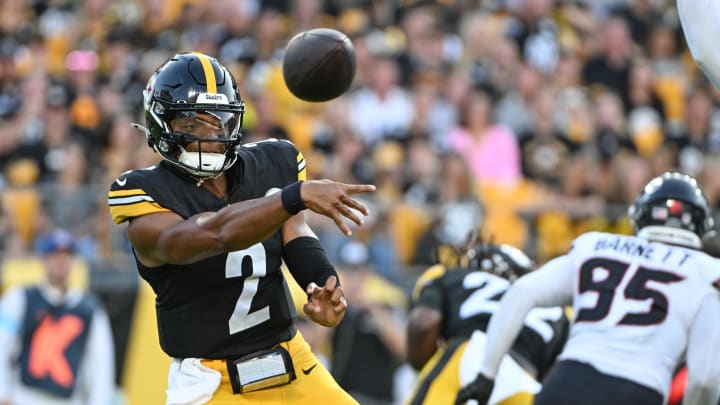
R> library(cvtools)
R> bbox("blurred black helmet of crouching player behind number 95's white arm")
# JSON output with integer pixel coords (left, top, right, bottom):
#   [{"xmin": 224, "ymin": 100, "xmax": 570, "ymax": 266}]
[{"xmin": 467, "ymin": 242, "xmax": 535, "ymax": 283}]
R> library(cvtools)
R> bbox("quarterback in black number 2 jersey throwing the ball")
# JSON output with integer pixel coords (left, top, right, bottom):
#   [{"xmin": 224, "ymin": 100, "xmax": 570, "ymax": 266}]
[{"xmin": 108, "ymin": 53, "xmax": 374, "ymax": 404}]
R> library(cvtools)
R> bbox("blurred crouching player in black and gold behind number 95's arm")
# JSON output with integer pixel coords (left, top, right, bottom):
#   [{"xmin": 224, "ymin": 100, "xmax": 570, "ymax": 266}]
[{"xmin": 408, "ymin": 243, "xmax": 568, "ymax": 405}]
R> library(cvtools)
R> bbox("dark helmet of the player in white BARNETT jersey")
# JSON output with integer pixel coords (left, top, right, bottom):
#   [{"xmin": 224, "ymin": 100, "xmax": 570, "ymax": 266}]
[{"xmin": 628, "ymin": 172, "xmax": 714, "ymax": 248}]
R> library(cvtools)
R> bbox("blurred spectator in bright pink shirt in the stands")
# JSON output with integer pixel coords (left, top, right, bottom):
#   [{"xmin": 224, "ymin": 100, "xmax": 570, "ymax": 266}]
[{"xmin": 448, "ymin": 90, "xmax": 521, "ymax": 185}]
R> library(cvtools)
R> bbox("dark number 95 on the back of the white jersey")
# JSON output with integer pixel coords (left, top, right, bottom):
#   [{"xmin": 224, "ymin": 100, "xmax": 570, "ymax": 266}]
[{"xmin": 575, "ymin": 258, "xmax": 684, "ymax": 326}]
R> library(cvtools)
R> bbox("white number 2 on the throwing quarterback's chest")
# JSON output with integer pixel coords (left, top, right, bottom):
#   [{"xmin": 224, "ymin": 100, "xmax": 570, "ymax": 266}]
[{"xmin": 225, "ymin": 243, "xmax": 270, "ymax": 335}]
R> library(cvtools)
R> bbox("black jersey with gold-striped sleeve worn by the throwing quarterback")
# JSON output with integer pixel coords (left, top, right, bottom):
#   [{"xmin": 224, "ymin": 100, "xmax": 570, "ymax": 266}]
[{"xmin": 108, "ymin": 140, "xmax": 305, "ymax": 359}]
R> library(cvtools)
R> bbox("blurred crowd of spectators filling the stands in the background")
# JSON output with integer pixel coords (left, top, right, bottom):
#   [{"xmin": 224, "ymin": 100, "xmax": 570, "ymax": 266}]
[{"xmin": 0, "ymin": 0, "xmax": 720, "ymax": 274}]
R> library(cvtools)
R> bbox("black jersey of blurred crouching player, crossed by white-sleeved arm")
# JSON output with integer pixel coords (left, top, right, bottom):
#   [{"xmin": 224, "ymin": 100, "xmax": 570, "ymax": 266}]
[{"xmin": 413, "ymin": 265, "xmax": 569, "ymax": 376}]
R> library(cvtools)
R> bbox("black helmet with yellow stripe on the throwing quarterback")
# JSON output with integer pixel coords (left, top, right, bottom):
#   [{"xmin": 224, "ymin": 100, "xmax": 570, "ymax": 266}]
[{"xmin": 134, "ymin": 52, "xmax": 245, "ymax": 179}]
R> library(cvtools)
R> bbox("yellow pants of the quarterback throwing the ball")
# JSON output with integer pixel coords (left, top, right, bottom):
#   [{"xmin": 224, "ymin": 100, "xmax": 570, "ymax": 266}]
[{"xmin": 202, "ymin": 332, "xmax": 357, "ymax": 405}]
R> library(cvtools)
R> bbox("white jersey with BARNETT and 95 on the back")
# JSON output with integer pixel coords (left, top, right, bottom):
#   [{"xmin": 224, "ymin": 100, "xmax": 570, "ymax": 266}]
[{"xmin": 547, "ymin": 232, "xmax": 720, "ymax": 394}]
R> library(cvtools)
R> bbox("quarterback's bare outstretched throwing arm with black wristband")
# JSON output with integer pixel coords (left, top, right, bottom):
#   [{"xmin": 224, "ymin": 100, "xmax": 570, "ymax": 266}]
[{"xmin": 128, "ymin": 180, "xmax": 375, "ymax": 267}]
